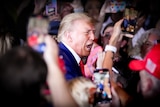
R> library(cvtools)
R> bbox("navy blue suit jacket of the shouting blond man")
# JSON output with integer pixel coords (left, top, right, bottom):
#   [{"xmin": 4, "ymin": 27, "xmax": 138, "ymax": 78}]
[{"xmin": 58, "ymin": 42, "xmax": 82, "ymax": 80}]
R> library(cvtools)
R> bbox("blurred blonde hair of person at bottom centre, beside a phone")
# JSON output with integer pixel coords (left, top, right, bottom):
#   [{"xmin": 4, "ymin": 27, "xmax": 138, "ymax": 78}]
[{"xmin": 68, "ymin": 77, "xmax": 96, "ymax": 107}]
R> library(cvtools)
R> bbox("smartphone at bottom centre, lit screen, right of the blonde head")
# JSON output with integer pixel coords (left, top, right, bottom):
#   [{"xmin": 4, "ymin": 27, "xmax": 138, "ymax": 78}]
[{"xmin": 93, "ymin": 69, "xmax": 112, "ymax": 104}]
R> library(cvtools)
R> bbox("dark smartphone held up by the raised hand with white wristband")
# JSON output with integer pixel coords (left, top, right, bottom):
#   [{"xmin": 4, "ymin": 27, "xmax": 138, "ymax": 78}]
[{"xmin": 121, "ymin": 8, "xmax": 138, "ymax": 34}]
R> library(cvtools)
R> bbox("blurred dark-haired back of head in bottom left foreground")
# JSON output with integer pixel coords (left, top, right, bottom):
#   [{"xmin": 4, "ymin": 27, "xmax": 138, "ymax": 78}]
[{"xmin": 0, "ymin": 47, "xmax": 47, "ymax": 107}]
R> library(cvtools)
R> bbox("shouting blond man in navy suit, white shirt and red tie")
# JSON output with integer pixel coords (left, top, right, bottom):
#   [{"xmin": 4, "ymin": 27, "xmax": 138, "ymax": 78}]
[{"xmin": 58, "ymin": 13, "xmax": 95, "ymax": 80}]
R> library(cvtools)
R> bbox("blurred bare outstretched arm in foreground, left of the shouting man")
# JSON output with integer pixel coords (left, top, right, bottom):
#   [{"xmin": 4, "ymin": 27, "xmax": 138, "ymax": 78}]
[{"xmin": 44, "ymin": 36, "xmax": 78, "ymax": 107}]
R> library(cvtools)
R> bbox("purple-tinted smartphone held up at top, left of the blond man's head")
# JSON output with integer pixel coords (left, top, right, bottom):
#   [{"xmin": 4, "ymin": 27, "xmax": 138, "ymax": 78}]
[{"xmin": 46, "ymin": 0, "xmax": 57, "ymax": 16}]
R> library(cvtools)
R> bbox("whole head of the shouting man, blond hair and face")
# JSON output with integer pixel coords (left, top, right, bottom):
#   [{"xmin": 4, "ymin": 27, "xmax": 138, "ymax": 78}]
[{"xmin": 58, "ymin": 13, "xmax": 95, "ymax": 57}]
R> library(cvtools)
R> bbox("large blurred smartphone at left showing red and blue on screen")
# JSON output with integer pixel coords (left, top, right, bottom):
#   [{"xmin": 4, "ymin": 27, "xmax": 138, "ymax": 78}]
[{"xmin": 27, "ymin": 16, "xmax": 49, "ymax": 53}]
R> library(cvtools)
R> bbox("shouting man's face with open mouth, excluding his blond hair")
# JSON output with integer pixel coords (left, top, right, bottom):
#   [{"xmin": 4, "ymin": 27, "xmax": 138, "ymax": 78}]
[{"xmin": 70, "ymin": 20, "xmax": 95, "ymax": 57}]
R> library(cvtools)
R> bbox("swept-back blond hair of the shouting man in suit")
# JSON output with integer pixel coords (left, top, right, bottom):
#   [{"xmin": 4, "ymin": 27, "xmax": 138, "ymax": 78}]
[{"xmin": 57, "ymin": 13, "xmax": 93, "ymax": 41}]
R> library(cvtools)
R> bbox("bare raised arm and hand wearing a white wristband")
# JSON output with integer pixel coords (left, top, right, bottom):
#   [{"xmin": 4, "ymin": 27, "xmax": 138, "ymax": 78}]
[{"xmin": 103, "ymin": 19, "xmax": 132, "ymax": 106}]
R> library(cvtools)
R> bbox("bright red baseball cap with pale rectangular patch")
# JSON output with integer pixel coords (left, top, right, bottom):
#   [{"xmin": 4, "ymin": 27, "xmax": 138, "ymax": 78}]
[{"xmin": 129, "ymin": 44, "xmax": 160, "ymax": 79}]
